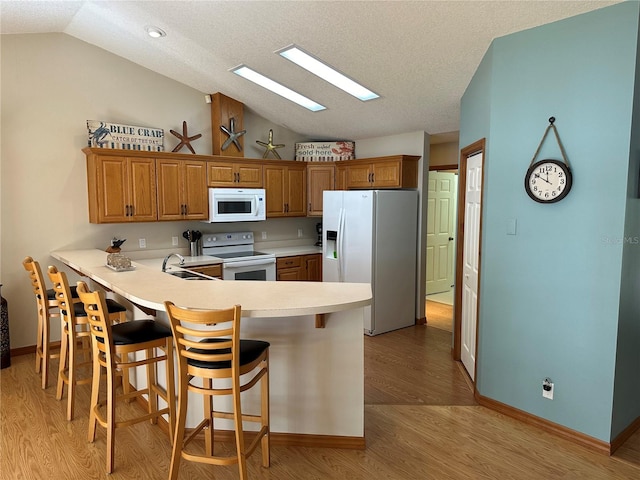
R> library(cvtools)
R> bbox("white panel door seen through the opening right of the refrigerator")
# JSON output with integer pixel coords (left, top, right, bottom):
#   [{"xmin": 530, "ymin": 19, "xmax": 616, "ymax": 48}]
[{"xmin": 426, "ymin": 171, "xmax": 458, "ymax": 295}]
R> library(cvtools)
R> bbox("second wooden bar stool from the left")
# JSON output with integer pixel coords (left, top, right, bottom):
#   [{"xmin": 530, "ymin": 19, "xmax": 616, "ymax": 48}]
[{"xmin": 48, "ymin": 266, "xmax": 129, "ymax": 420}]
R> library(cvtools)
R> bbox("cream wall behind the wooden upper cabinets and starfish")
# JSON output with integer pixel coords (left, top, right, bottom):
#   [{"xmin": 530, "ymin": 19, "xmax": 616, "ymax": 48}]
[{"xmin": 0, "ymin": 34, "xmax": 318, "ymax": 349}]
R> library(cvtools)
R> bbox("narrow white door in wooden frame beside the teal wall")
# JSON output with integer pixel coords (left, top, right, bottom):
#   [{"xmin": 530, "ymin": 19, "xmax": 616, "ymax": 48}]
[{"xmin": 460, "ymin": 153, "xmax": 483, "ymax": 379}]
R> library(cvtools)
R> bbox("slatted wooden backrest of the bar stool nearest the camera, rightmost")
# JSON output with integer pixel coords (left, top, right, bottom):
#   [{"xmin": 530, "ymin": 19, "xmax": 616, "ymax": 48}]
[{"xmin": 164, "ymin": 302, "xmax": 242, "ymax": 376}]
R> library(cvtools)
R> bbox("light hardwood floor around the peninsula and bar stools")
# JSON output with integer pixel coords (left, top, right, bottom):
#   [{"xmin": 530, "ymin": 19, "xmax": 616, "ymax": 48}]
[{"xmin": 0, "ymin": 326, "xmax": 640, "ymax": 480}]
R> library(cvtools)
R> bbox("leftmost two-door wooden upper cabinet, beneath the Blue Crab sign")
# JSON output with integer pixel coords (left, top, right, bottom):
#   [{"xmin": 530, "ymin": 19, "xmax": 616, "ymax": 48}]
[{"xmin": 85, "ymin": 148, "xmax": 158, "ymax": 223}]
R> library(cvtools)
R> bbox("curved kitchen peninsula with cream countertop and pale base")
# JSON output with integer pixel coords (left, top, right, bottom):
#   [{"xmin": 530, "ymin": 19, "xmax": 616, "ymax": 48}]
[{"xmin": 51, "ymin": 250, "xmax": 371, "ymax": 448}]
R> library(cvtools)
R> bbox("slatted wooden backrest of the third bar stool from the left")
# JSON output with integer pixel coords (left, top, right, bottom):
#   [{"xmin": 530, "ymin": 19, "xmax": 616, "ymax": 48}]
[{"xmin": 77, "ymin": 281, "xmax": 115, "ymax": 367}]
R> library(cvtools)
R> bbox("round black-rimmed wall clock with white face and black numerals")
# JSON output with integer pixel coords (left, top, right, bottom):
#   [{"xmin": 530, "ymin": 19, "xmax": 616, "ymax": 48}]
[{"xmin": 524, "ymin": 160, "xmax": 572, "ymax": 203}]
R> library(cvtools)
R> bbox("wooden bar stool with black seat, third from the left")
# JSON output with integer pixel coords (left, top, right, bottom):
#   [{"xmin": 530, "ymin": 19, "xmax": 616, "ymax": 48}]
[{"xmin": 78, "ymin": 282, "xmax": 176, "ymax": 473}]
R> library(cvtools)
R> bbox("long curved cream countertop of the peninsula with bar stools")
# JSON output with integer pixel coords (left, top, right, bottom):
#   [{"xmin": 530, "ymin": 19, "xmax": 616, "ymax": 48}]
[{"xmin": 51, "ymin": 247, "xmax": 371, "ymax": 317}]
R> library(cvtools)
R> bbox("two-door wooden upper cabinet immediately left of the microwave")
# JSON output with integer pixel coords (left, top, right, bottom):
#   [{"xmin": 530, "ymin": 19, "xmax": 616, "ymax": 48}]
[{"xmin": 156, "ymin": 159, "xmax": 209, "ymax": 220}]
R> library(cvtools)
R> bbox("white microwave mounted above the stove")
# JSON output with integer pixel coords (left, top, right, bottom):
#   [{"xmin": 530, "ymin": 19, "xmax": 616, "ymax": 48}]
[{"xmin": 209, "ymin": 188, "xmax": 267, "ymax": 223}]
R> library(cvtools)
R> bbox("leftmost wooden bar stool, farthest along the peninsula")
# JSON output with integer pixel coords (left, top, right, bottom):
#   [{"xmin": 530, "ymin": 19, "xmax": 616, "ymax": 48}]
[{"xmin": 22, "ymin": 257, "xmax": 80, "ymax": 388}]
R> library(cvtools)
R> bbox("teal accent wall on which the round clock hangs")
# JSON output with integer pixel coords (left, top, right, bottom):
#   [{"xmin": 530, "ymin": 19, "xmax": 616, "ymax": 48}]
[{"xmin": 460, "ymin": 2, "xmax": 640, "ymax": 442}]
